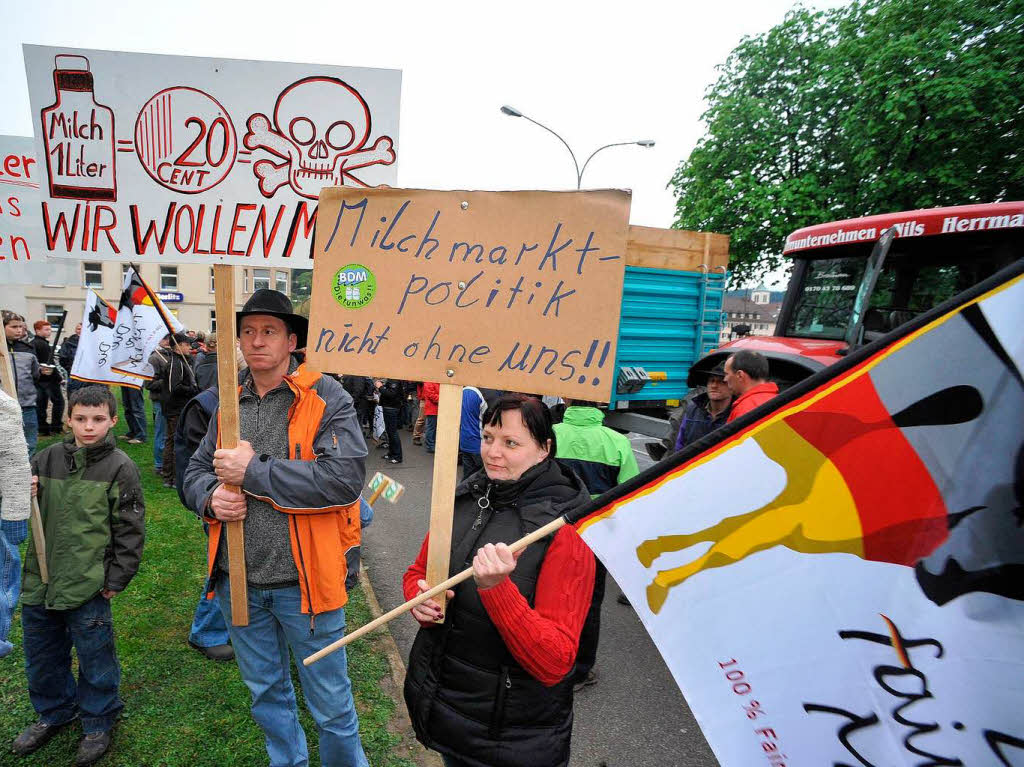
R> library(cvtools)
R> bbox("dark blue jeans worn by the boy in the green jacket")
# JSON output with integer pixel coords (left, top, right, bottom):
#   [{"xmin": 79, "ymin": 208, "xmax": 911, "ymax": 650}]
[{"xmin": 22, "ymin": 594, "xmax": 124, "ymax": 735}]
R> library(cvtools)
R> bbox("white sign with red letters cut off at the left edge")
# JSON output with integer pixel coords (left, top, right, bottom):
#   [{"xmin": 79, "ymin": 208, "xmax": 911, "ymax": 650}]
[{"xmin": 0, "ymin": 136, "xmax": 82, "ymax": 286}]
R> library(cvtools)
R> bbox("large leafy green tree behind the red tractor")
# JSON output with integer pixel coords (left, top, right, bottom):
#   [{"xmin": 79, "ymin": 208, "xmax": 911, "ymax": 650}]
[{"xmin": 671, "ymin": 0, "xmax": 1024, "ymax": 284}]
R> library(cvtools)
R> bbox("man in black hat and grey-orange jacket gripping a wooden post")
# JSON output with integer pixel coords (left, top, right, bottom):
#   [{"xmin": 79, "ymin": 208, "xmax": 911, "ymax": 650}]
[{"xmin": 183, "ymin": 289, "xmax": 368, "ymax": 767}]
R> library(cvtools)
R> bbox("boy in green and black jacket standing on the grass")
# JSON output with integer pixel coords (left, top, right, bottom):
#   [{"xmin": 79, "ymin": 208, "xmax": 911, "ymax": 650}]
[{"xmin": 11, "ymin": 386, "xmax": 145, "ymax": 765}]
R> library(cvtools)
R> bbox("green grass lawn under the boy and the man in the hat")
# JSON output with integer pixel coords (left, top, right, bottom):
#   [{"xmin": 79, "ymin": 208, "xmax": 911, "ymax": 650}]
[{"xmin": 0, "ymin": 397, "xmax": 414, "ymax": 767}]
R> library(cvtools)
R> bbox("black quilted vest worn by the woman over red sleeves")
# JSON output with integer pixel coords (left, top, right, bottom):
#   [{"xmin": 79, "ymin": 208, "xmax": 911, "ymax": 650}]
[{"xmin": 406, "ymin": 460, "xmax": 590, "ymax": 767}]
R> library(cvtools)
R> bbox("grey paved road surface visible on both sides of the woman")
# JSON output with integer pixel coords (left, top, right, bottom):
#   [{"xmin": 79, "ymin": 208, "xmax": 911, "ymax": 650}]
[{"xmin": 364, "ymin": 430, "xmax": 718, "ymax": 767}]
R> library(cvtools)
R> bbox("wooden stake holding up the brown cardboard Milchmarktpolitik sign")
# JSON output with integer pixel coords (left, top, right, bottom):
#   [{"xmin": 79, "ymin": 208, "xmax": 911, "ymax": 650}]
[{"xmin": 427, "ymin": 384, "xmax": 462, "ymax": 613}]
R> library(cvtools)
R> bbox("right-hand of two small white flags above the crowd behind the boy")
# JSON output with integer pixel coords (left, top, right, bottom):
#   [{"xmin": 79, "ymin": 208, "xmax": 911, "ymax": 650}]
[{"xmin": 111, "ymin": 267, "xmax": 183, "ymax": 383}]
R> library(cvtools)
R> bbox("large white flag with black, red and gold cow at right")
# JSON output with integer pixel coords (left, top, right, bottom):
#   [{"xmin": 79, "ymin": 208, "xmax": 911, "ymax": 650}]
[{"xmin": 569, "ymin": 261, "xmax": 1024, "ymax": 767}]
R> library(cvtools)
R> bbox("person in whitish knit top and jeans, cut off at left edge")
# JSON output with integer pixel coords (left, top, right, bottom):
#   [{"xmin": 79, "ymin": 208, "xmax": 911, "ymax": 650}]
[{"xmin": 0, "ymin": 390, "xmax": 32, "ymax": 657}]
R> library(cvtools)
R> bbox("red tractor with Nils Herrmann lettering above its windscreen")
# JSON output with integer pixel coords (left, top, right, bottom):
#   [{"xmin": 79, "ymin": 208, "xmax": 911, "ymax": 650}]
[{"xmin": 687, "ymin": 202, "xmax": 1024, "ymax": 388}]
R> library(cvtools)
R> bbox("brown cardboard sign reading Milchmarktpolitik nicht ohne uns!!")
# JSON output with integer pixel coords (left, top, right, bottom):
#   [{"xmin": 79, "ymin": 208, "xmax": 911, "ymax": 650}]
[{"xmin": 307, "ymin": 188, "xmax": 630, "ymax": 400}]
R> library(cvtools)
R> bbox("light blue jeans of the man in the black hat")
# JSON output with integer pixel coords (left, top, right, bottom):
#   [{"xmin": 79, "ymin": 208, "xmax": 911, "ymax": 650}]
[{"xmin": 216, "ymin": 576, "xmax": 370, "ymax": 767}]
